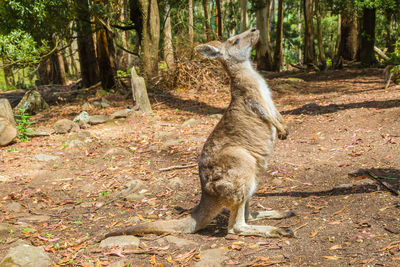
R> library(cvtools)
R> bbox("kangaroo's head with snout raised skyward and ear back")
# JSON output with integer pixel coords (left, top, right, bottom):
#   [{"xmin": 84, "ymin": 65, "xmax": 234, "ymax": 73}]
[{"xmin": 196, "ymin": 29, "xmax": 260, "ymax": 66}]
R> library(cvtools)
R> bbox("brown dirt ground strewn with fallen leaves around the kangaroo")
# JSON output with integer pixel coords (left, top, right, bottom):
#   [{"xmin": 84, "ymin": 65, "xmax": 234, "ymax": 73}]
[{"xmin": 0, "ymin": 66, "xmax": 400, "ymax": 266}]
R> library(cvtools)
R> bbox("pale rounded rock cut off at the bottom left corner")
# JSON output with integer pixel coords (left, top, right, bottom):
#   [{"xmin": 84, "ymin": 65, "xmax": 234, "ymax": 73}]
[{"xmin": 0, "ymin": 244, "xmax": 51, "ymax": 267}]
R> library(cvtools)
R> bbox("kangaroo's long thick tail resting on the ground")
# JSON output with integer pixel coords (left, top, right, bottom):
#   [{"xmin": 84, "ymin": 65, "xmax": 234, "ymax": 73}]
[{"xmin": 105, "ymin": 194, "xmax": 222, "ymax": 237}]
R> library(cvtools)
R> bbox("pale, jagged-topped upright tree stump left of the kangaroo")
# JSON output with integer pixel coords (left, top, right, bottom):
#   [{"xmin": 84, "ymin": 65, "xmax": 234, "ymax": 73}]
[{"xmin": 131, "ymin": 67, "xmax": 152, "ymax": 113}]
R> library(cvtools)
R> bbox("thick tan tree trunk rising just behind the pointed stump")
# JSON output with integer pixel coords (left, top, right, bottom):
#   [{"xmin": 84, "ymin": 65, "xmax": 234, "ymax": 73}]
[{"xmin": 139, "ymin": 0, "xmax": 160, "ymax": 80}]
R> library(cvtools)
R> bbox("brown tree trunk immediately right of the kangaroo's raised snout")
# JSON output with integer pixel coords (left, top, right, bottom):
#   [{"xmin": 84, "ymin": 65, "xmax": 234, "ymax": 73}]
[{"xmin": 256, "ymin": 0, "xmax": 272, "ymax": 71}]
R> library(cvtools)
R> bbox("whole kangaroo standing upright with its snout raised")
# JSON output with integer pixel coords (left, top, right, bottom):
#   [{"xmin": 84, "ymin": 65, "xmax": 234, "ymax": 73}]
[{"xmin": 106, "ymin": 29, "xmax": 294, "ymax": 237}]
